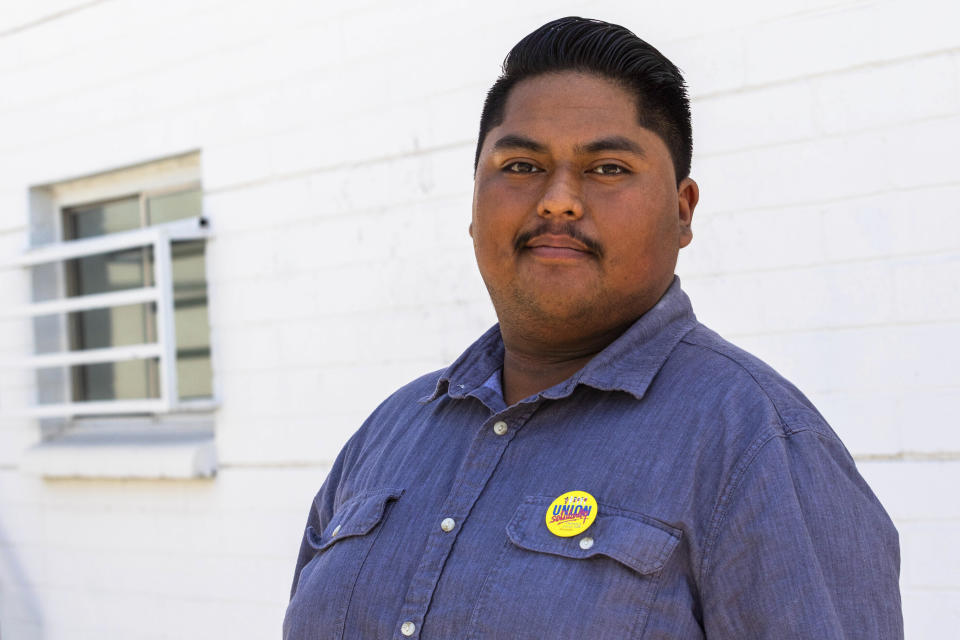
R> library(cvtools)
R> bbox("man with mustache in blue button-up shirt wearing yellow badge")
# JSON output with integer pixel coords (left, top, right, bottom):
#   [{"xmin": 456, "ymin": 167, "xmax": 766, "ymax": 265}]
[{"xmin": 284, "ymin": 18, "xmax": 902, "ymax": 640}]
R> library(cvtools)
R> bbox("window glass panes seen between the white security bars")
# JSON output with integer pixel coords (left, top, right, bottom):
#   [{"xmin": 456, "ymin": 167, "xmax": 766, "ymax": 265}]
[{"xmin": 63, "ymin": 189, "xmax": 212, "ymax": 402}]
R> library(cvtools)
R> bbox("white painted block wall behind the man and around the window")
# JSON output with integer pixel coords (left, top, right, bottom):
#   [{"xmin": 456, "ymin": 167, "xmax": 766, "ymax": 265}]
[{"xmin": 0, "ymin": 0, "xmax": 960, "ymax": 640}]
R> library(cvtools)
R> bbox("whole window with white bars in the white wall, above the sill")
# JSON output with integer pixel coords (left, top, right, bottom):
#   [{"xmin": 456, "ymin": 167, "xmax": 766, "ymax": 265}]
[{"xmin": 18, "ymin": 154, "xmax": 214, "ymax": 417}]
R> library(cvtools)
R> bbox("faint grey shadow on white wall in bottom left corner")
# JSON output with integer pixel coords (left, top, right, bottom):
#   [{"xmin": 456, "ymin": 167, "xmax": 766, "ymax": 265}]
[{"xmin": 0, "ymin": 522, "xmax": 43, "ymax": 640}]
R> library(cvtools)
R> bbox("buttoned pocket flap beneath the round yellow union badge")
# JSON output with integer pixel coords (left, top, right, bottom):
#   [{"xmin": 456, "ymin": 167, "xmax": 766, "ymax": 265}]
[{"xmin": 507, "ymin": 496, "xmax": 681, "ymax": 574}]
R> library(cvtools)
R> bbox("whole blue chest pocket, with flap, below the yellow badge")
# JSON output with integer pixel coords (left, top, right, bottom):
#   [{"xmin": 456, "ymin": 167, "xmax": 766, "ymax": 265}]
[{"xmin": 471, "ymin": 496, "xmax": 681, "ymax": 639}]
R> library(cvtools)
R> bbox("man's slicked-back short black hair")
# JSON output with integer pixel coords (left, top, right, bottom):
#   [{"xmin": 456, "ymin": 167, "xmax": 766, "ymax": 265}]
[{"xmin": 473, "ymin": 17, "xmax": 693, "ymax": 184}]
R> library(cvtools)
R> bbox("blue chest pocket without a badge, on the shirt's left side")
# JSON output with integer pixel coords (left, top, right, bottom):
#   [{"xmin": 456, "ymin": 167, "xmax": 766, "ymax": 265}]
[{"xmin": 283, "ymin": 488, "xmax": 403, "ymax": 640}]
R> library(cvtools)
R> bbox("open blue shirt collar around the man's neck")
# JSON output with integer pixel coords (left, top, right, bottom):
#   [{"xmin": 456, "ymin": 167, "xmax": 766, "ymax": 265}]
[{"xmin": 421, "ymin": 276, "xmax": 697, "ymax": 402}]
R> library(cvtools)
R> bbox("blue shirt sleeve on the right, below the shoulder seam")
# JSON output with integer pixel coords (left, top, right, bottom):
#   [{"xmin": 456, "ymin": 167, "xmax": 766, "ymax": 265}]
[{"xmin": 701, "ymin": 431, "xmax": 903, "ymax": 640}]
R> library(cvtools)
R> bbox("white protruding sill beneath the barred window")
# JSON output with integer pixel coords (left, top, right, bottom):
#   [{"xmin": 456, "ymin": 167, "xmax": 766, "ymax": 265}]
[{"xmin": 20, "ymin": 419, "xmax": 217, "ymax": 479}]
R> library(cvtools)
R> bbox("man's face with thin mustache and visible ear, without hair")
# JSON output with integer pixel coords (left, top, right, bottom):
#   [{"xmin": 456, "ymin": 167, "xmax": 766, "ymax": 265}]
[{"xmin": 470, "ymin": 72, "xmax": 698, "ymax": 342}]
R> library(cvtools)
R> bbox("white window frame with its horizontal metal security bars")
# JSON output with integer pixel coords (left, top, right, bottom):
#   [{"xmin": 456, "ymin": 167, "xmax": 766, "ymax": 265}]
[{"xmin": 0, "ymin": 153, "xmax": 218, "ymax": 419}]
